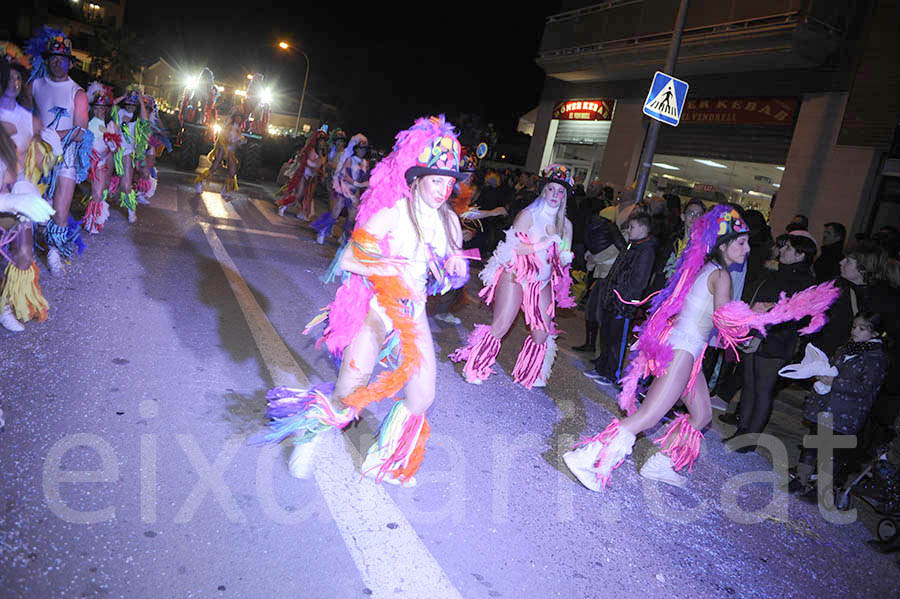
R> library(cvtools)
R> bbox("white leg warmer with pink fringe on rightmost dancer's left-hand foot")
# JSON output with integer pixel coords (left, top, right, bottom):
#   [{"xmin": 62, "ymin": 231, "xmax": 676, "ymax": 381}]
[{"xmin": 563, "ymin": 418, "xmax": 635, "ymax": 491}]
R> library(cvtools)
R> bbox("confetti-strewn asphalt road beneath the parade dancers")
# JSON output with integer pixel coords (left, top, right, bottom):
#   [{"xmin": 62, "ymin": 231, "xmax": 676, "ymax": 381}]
[{"xmin": 0, "ymin": 169, "xmax": 900, "ymax": 599}]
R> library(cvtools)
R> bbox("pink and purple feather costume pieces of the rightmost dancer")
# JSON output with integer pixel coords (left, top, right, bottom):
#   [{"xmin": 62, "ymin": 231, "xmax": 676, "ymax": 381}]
[{"xmin": 563, "ymin": 205, "xmax": 838, "ymax": 491}]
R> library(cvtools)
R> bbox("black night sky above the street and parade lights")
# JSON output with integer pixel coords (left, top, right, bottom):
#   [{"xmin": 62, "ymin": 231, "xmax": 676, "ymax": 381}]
[{"xmin": 126, "ymin": 0, "xmax": 559, "ymax": 144}]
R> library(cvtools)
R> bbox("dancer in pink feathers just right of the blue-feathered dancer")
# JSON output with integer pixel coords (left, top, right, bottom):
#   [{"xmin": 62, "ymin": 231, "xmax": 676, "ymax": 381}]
[{"xmin": 83, "ymin": 81, "xmax": 122, "ymax": 235}]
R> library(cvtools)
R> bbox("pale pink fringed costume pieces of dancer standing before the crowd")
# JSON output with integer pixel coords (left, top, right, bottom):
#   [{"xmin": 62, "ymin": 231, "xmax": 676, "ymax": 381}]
[{"xmin": 449, "ymin": 167, "xmax": 575, "ymax": 389}]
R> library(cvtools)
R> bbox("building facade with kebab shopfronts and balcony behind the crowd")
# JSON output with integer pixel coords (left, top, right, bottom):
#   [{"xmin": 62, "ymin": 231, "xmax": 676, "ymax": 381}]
[{"xmin": 526, "ymin": 0, "xmax": 900, "ymax": 236}]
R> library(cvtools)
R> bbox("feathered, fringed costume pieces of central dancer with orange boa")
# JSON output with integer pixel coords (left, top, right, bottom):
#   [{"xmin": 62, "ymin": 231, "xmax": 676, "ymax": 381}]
[{"xmin": 251, "ymin": 116, "xmax": 468, "ymax": 484}]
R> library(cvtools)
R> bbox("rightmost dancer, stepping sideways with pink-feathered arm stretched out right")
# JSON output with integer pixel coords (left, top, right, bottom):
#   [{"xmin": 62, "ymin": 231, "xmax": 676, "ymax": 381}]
[{"xmin": 563, "ymin": 204, "xmax": 837, "ymax": 491}]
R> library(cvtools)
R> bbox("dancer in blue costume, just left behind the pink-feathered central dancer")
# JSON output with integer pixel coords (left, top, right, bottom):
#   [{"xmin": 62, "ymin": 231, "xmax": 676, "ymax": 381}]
[{"xmin": 312, "ymin": 133, "xmax": 369, "ymax": 245}]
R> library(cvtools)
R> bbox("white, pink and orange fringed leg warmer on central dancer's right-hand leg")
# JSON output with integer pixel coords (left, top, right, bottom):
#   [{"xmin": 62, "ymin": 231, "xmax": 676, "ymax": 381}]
[{"xmin": 362, "ymin": 401, "xmax": 431, "ymax": 487}]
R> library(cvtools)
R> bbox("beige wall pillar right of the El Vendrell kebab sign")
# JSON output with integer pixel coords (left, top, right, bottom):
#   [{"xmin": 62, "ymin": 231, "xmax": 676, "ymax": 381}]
[{"xmin": 770, "ymin": 93, "xmax": 881, "ymax": 238}]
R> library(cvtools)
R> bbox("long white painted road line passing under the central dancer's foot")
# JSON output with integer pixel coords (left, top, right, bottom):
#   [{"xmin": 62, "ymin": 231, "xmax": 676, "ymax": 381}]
[{"xmin": 200, "ymin": 223, "xmax": 462, "ymax": 599}]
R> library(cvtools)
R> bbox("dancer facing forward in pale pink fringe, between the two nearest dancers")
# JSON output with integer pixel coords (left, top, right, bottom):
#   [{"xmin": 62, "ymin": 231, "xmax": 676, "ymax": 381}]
[{"xmin": 450, "ymin": 165, "xmax": 575, "ymax": 389}]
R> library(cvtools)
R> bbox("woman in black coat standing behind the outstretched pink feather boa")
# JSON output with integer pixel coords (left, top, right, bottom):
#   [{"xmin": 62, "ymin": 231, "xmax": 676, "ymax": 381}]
[{"xmin": 725, "ymin": 231, "xmax": 816, "ymax": 453}]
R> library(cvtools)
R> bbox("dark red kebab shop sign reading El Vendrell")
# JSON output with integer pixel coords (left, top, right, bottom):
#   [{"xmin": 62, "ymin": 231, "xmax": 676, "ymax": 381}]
[{"xmin": 681, "ymin": 98, "xmax": 800, "ymax": 125}]
